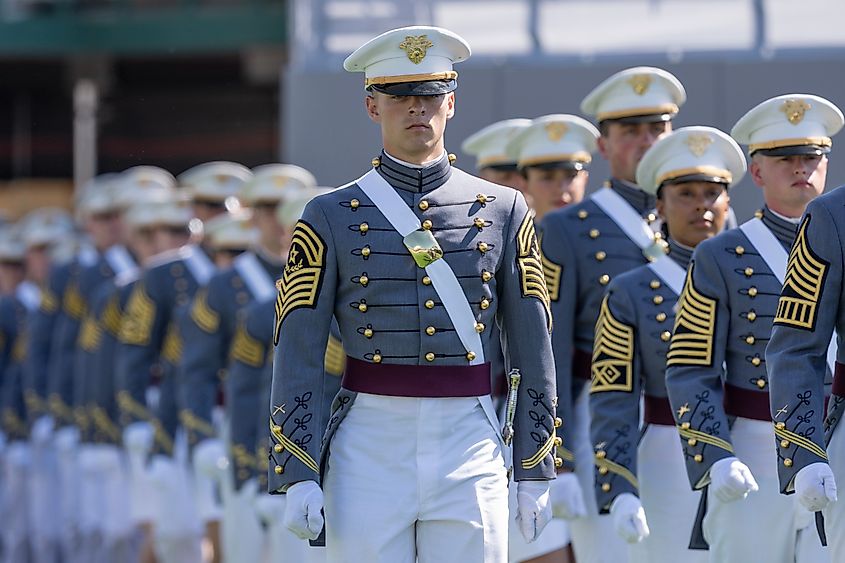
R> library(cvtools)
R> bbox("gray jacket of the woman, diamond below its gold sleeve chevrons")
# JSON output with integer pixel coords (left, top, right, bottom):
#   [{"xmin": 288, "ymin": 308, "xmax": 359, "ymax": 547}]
[{"xmin": 590, "ymin": 239, "xmax": 692, "ymax": 512}]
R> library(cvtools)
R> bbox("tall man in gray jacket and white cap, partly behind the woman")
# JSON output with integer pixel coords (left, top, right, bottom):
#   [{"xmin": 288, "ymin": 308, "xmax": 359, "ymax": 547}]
[{"xmin": 541, "ymin": 67, "xmax": 686, "ymax": 562}]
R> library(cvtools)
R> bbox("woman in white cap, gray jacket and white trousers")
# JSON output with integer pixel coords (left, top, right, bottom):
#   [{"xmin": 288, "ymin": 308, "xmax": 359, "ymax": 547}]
[{"xmin": 590, "ymin": 127, "xmax": 746, "ymax": 563}]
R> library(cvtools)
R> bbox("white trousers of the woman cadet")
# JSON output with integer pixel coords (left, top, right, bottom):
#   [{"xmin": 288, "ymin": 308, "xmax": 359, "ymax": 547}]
[{"xmin": 630, "ymin": 424, "xmax": 707, "ymax": 563}]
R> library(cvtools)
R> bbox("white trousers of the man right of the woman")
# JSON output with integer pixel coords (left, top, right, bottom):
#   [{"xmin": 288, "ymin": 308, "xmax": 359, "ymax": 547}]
[{"xmin": 703, "ymin": 418, "xmax": 824, "ymax": 563}]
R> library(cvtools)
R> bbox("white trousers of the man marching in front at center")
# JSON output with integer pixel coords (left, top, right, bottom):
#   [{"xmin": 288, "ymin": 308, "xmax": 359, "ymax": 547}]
[{"xmin": 323, "ymin": 393, "xmax": 508, "ymax": 563}]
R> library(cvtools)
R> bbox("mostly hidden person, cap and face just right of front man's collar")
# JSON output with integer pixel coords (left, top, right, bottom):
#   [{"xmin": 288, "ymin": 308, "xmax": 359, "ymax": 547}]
[{"xmin": 461, "ymin": 119, "xmax": 531, "ymax": 191}]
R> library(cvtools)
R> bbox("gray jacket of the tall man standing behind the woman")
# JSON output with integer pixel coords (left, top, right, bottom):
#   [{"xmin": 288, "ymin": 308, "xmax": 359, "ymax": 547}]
[{"xmin": 540, "ymin": 179, "xmax": 656, "ymax": 469}]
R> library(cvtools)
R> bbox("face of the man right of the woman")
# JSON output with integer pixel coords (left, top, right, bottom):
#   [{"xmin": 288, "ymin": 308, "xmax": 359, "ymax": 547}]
[{"xmin": 750, "ymin": 154, "xmax": 828, "ymax": 217}]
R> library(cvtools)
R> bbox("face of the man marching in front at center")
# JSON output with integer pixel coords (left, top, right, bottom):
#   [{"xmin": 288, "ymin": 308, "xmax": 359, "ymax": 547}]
[{"xmin": 366, "ymin": 92, "xmax": 455, "ymax": 164}]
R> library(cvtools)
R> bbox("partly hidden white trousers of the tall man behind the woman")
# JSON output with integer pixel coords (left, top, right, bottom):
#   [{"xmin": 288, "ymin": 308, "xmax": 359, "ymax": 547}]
[{"xmin": 564, "ymin": 384, "xmax": 628, "ymax": 563}]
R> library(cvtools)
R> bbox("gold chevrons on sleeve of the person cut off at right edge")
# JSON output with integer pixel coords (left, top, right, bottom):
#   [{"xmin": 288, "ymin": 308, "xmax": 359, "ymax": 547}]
[{"xmin": 774, "ymin": 215, "xmax": 829, "ymax": 331}]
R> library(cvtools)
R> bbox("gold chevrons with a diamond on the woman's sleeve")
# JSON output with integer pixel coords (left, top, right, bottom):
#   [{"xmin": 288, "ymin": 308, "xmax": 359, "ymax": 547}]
[{"xmin": 590, "ymin": 295, "xmax": 634, "ymax": 393}]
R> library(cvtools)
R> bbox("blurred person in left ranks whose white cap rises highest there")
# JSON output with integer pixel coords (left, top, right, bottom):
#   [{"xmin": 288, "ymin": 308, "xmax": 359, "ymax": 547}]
[{"xmin": 115, "ymin": 162, "xmax": 252, "ymax": 561}]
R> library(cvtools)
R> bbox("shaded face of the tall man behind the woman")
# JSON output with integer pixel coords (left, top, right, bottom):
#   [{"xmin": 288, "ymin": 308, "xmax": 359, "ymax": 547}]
[{"xmin": 598, "ymin": 121, "xmax": 672, "ymax": 183}]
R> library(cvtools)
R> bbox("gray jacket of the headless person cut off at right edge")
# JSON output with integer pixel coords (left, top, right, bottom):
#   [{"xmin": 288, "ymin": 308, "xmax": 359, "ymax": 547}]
[{"xmin": 766, "ymin": 188, "xmax": 845, "ymax": 490}]
